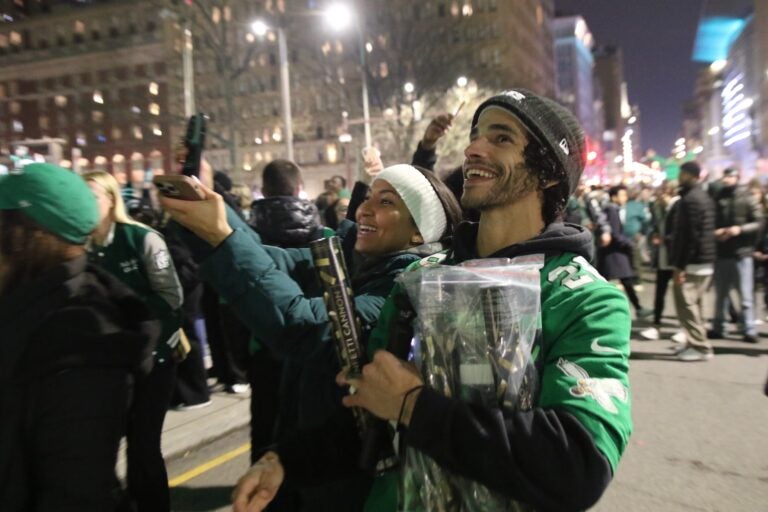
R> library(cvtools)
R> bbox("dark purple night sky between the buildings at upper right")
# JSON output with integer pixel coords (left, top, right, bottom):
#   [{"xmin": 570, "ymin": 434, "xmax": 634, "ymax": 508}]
[{"xmin": 555, "ymin": 0, "xmax": 704, "ymax": 155}]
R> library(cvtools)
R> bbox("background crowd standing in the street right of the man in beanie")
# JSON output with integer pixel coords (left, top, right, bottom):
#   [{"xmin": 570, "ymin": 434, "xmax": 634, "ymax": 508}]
[{"xmin": 568, "ymin": 161, "xmax": 768, "ymax": 361}]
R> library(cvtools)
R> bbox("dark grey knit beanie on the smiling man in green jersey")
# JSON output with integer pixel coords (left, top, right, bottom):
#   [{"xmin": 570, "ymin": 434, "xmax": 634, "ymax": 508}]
[{"xmin": 472, "ymin": 89, "xmax": 586, "ymax": 194}]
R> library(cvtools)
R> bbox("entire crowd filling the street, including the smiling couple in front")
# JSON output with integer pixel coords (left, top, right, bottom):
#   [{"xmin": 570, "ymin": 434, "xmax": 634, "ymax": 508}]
[{"xmin": 0, "ymin": 85, "xmax": 768, "ymax": 512}]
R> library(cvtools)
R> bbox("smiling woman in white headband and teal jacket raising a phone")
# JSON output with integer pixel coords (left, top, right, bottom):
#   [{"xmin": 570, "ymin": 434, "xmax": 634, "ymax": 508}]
[{"xmin": 161, "ymin": 165, "xmax": 461, "ymax": 510}]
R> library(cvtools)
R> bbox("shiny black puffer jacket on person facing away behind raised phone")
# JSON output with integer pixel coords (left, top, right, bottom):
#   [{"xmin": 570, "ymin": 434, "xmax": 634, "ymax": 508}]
[{"xmin": 248, "ymin": 196, "xmax": 323, "ymax": 247}]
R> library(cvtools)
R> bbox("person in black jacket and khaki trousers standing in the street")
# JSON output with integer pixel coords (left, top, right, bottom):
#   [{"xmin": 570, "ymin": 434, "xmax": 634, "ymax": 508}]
[{"xmin": 670, "ymin": 162, "xmax": 715, "ymax": 361}]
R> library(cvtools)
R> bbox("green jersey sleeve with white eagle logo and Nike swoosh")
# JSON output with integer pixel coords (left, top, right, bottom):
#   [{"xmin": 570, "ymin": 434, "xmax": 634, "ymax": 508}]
[{"xmin": 538, "ymin": 253, "xmax": 632, "ymax": 471}]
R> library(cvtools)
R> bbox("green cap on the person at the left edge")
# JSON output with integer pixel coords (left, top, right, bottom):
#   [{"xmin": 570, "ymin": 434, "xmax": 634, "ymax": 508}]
[{"xmin": 0, "ymin": 164, "xmax": 99, "ymax": 245}]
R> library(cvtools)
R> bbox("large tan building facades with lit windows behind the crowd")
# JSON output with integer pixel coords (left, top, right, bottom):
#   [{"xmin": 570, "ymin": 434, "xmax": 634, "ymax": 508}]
[{"xmin": 0, "ymin": 0, "xmax": 555, "ymax": 195}]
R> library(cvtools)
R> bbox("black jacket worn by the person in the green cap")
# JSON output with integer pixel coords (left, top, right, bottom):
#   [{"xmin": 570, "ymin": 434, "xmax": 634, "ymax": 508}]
[{"xmin": 0, "ymin": 256, "xmax": 160, "ymax": 512}]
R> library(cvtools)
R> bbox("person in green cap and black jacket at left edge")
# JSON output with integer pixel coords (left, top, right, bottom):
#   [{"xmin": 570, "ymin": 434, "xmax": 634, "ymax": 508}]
[{"xmin": 0, "ymin": 164, "xmax": 160, "ymax": 512}]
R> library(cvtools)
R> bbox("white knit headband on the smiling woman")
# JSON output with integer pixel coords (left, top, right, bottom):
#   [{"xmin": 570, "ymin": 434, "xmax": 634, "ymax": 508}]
[{"xmin": 373, "ymin": 164, "xmax": 448, "ymax": 243}]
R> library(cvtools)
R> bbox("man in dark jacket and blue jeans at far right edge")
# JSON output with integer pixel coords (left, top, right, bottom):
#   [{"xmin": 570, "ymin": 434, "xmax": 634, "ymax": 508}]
[{"xmin": 708, "ymin": 168, "xmax": 763, "ymax": 343}]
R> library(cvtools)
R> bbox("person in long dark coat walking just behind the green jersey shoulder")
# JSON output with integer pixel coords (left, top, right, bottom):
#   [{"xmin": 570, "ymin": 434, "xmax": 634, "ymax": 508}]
[{"xmin": 597, "ymin": 185, "xmax": 653, "ymax": 318}]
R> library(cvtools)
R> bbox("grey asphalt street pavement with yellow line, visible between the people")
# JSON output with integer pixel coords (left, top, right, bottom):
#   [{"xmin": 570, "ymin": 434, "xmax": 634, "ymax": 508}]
[{"xmin": 163, "ymin": 282, "xmax": 768, "ymax": 512}]
